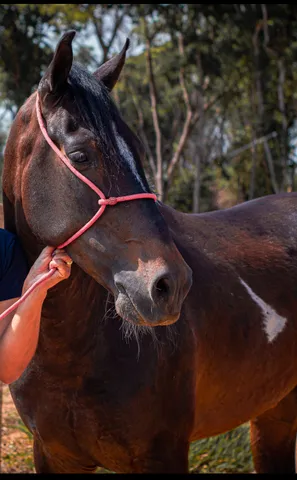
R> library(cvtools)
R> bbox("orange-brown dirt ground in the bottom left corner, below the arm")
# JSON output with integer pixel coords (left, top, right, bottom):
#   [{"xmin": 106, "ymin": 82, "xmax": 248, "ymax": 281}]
[{"xmin": 0, "ymin": 384, "xmax": 35, "ymax": 473}]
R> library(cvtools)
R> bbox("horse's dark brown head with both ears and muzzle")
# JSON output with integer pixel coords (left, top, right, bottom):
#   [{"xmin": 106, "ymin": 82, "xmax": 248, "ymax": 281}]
[{"xmin": 3, "ymin": 31, "xmax": 192, "ymax": 326}]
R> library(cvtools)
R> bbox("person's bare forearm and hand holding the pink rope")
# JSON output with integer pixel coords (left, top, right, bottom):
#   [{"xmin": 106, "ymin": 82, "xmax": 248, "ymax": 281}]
[{"xmin": 0, "ymin": 247, "xmax": 72, "ymax": 384}]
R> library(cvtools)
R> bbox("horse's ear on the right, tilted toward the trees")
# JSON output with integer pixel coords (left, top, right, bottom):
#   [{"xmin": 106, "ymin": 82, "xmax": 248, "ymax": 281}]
[{"xmin": 93, "ymin": 38, "xmax": 130, "ymax": 91}]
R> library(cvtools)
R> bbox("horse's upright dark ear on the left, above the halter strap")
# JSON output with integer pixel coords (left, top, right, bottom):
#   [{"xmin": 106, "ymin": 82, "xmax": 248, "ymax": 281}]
[{"xmin": 38, "ymin": 30, "xmax": 76, "ymax": 107}]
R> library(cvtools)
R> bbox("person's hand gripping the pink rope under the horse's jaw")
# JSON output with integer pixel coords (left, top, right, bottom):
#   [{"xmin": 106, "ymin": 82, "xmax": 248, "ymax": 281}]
[{"xmin": 23, "ymin": 246, "xmax": 72, "ymax": 295}]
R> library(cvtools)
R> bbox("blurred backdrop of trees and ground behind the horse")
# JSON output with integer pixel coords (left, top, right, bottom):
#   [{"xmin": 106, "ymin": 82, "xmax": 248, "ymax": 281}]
[{"xmin": 0, "ymin": 4, "xmax": 297, "ymax": 473}]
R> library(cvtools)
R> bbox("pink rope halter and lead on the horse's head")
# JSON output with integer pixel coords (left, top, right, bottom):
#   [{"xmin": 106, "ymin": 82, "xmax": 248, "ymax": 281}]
[{"xmin": 0, "ymin": 93, "xmax": 157, "ymax": 320}]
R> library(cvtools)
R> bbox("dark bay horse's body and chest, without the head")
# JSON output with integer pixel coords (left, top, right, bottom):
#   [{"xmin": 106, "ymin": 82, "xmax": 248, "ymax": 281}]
[{"xmin": 5, "ymin": 190, "xmax": 297, "ymax": 472}]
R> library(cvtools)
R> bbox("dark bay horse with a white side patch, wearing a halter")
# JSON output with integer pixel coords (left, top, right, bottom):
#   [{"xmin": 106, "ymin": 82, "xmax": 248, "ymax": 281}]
[{"xmin": 2, "ymin": 31, "xmax": 297, "ymax": 473}]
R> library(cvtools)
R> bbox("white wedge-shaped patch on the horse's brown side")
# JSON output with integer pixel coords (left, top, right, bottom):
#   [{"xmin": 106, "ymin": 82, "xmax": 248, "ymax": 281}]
[{"xmin": 239, "ymin": 277, "xmax": 287, "ymax": 342}]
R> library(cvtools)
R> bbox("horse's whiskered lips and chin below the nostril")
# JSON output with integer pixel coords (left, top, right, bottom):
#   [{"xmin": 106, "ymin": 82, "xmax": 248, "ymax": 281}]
[{"xmin": 115, "ymin": 292, "xmax": 180, "ymax": 327}]
